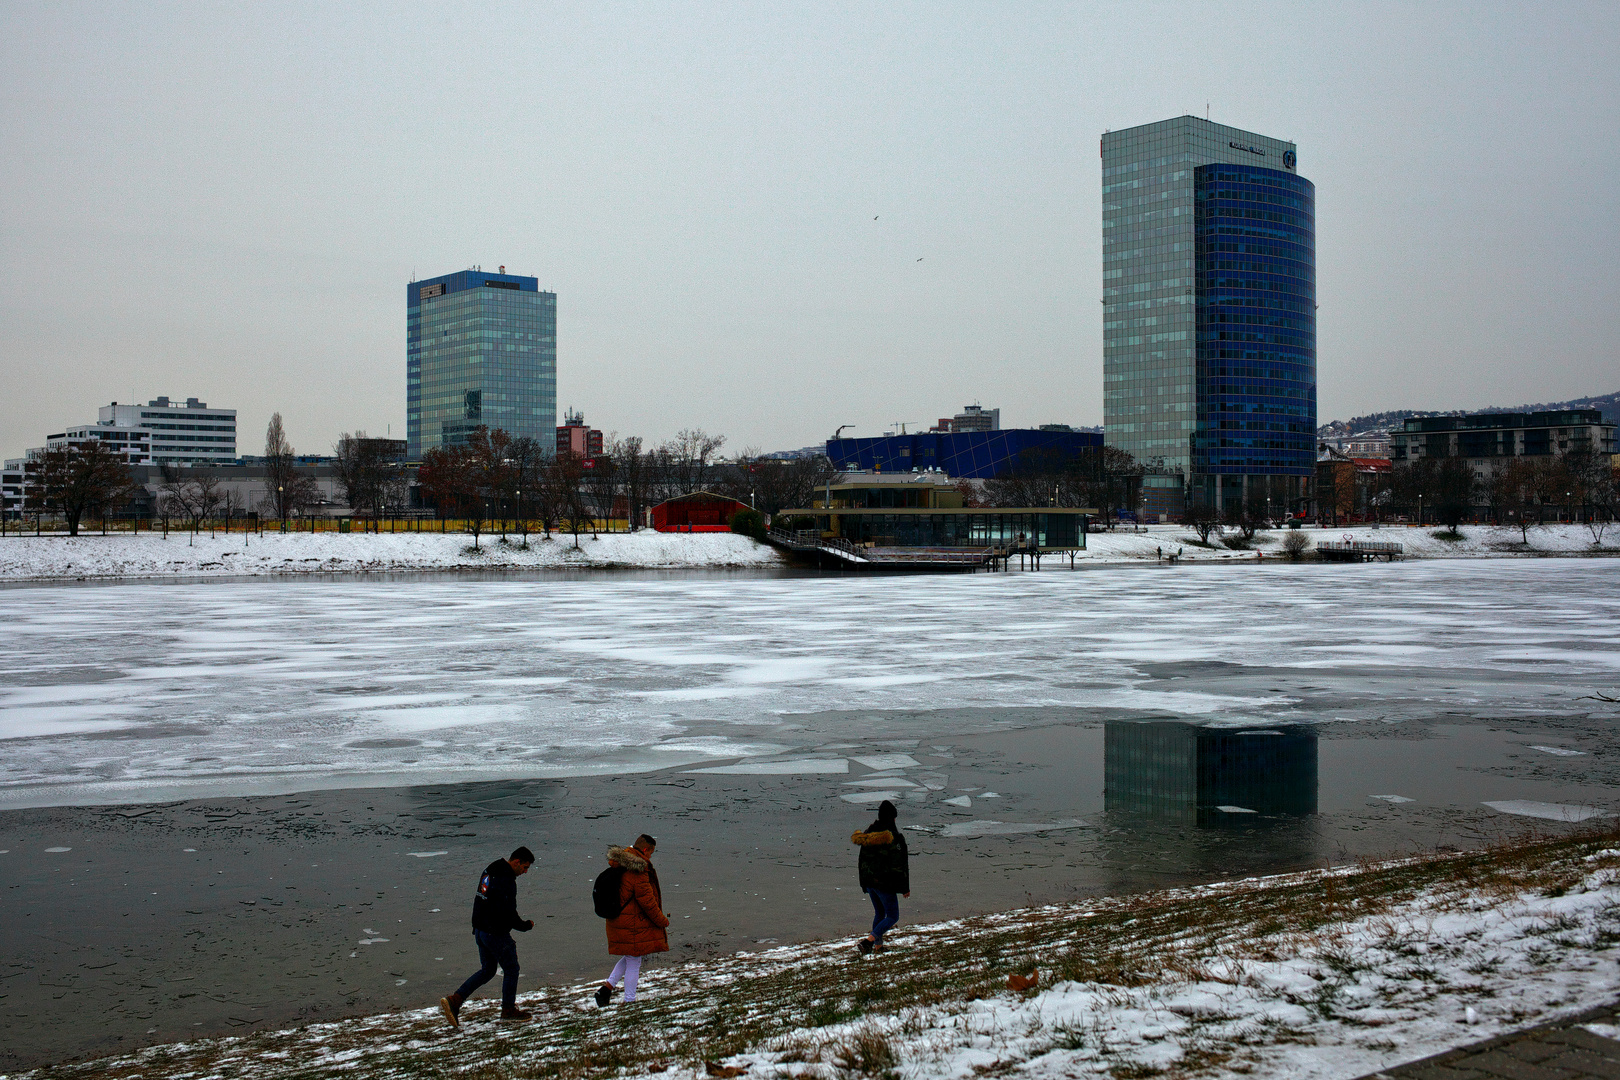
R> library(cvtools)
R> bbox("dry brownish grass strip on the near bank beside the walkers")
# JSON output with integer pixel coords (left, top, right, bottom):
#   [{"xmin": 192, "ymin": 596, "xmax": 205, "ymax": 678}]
[{"xmin": 31, "ymin": 826, "xmax": 1620, "ymax": 1080}]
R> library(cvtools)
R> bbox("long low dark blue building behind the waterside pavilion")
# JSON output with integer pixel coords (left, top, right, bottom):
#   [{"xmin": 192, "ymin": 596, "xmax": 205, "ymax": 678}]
[{"xmin": 826, "ymin": 427, "xmax": 1103, "ymax": 479}]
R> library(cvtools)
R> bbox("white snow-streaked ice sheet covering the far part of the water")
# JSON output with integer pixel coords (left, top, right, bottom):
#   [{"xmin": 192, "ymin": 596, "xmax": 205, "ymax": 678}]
[{"xmin": 0, "ymin": 559, "xmax": 1620, "ymax": 806}]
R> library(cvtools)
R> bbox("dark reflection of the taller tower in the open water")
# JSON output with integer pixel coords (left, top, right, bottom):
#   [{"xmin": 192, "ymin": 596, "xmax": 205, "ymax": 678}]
[{"xmin": 1103, "ymin": 721, "xmax": 1317, "ymax": 824}]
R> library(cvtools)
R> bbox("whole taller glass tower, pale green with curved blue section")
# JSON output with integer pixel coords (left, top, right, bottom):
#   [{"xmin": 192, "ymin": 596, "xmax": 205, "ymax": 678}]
[{"xmin": 1102, "ymin": 117, "xmax": 1315, "ymax": 513}]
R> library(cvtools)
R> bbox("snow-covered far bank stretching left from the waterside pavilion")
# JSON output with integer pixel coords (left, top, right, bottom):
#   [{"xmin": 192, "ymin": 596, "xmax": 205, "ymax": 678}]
[{"xmin": 0, "ymin": 529, "xmax": 781, "ymax": 581}]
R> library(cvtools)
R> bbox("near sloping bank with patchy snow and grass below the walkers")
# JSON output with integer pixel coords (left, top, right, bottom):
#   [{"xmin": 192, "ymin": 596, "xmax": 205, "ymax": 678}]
[{"xmin": 9, "ymin": 832, "xmax": 1620, "ymax": 1080}]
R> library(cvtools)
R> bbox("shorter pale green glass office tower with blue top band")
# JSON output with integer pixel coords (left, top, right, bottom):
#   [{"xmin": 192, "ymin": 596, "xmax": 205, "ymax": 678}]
[{"xmin": 405, "ymin": 270, "xmax": 557, "ymax": 461}]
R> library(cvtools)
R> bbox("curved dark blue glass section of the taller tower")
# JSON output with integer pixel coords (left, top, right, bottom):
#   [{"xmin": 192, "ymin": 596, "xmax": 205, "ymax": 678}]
[{"xmin": 1189, "ymin": 165, "xmax": 1317, "ymax": 513}]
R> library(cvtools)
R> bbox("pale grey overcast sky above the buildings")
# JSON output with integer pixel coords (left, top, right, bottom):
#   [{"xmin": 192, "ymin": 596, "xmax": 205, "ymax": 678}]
[{"xmin": 0, "ymin": 0, "xmax": 1620, "ymax": 455}]
